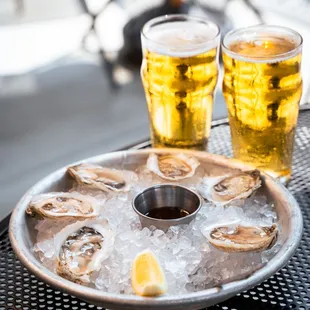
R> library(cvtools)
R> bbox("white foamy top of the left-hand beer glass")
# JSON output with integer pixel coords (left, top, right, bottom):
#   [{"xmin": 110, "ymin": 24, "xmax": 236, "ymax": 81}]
[{"xmin": 142, "ymin": 20, "xmax": 219, "ymax": 57}]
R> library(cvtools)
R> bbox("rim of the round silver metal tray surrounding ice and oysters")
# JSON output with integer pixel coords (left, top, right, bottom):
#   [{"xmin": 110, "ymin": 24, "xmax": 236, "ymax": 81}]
[{"xmin": 9, "ymin": 149, "xmax": 302, "ymax": 310}]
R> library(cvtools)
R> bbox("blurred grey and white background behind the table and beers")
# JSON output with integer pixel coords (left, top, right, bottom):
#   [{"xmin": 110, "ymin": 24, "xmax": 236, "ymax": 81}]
[{"xmin": 0, "ymin": 0, "xmax": 310, "ymax": 218}]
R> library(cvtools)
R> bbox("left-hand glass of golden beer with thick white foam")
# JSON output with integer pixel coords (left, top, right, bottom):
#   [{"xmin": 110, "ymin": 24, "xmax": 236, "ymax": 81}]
[{"xmin": 141, "ymin": 15, "xmax": 220, "ymax": 149}]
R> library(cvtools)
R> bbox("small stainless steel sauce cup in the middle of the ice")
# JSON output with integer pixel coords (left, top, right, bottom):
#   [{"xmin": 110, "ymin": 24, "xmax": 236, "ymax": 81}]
[{"xmin": 132, "ymin": 184, "xmax": 202, "ymax": 231}]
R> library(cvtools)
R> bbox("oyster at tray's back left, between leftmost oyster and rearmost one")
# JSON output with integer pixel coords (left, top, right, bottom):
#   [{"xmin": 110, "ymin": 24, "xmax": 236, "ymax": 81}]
[{"xmin": 68, "ymin": 164, "xmax": 136, "ymax": 192}]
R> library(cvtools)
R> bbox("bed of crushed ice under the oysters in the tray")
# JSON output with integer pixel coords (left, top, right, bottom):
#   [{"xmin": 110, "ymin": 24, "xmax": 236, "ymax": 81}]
[{"xmin": 34, "ymin": 168, "xmax": 279, "ymax": 294}]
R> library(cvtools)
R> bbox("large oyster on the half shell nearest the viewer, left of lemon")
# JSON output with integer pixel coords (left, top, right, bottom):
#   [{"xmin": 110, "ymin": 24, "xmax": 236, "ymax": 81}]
[{"xmin": 55, "ymin": 219, "xmax": 114, "ymax": 284}]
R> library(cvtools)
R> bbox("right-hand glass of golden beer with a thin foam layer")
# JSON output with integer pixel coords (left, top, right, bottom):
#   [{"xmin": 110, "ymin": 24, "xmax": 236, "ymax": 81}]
[{"xmin": 222, "ymin": 25, "xmax": 302, "ymax": 183}]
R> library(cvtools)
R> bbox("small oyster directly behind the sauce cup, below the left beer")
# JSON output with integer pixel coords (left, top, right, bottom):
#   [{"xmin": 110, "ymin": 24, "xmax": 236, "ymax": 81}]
[{"xmin": 146, "ymin": 154, "xmax": 199, "ymax": 181}]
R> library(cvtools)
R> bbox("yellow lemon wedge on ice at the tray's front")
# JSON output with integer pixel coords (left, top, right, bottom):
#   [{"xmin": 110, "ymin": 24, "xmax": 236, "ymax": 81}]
[{"xmin": 131, "ymin": 250, "xmax": 168, "ymax": 296}]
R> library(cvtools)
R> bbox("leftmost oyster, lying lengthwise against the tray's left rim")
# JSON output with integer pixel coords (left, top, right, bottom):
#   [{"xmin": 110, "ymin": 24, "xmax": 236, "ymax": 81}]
[{"xmin": 26, "ymin": 192, "xmax": 100, "ymax": 219}]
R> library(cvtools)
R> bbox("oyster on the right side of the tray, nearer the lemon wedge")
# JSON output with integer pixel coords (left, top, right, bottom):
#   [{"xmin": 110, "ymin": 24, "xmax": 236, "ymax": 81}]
[{"xmin": 207, "ymin": 224, "xmax": 278, "ymax": 252}]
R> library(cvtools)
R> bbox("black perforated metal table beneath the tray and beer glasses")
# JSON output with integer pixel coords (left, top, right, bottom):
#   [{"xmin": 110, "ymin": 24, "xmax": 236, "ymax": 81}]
[{"xmin": 0, "ymin": 106, "xmax": 310, "ymax": 310}]
